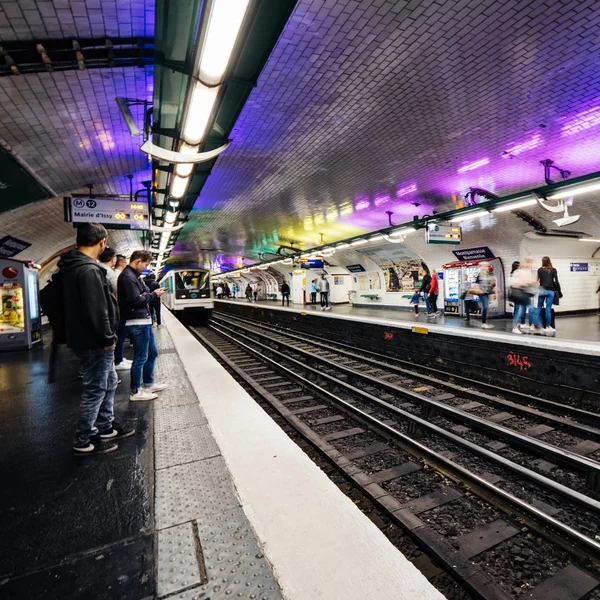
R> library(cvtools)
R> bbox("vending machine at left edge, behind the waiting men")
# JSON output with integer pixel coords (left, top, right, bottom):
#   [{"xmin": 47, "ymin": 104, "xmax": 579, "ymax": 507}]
[{"xmin": 0, "ymin": 258, "xmax": 42, "ymax": 350}]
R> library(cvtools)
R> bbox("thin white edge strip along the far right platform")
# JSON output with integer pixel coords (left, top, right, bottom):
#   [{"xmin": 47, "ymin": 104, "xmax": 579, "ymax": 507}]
[{"xmin": 215, "ymin": 300, "xmax": 600, "ymax": 356}]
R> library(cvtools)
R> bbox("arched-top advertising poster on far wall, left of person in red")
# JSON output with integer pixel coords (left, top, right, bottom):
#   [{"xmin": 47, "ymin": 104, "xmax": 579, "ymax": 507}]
[{"xmin": 361, "ymin": 244, "xmax": 424, "ymax": 292}]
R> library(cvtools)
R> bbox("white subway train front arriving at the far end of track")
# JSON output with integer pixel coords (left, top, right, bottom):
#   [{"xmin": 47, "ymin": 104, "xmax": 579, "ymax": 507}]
[{"xmin": 160, "ymin": 269, "xmax": 214, "ymax": 321}]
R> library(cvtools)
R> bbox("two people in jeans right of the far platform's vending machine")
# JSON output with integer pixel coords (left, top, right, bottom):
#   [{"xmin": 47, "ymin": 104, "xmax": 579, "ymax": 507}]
[{"xmin": 508, "ymin": 256, "xmax": 562, "ymax": 335}]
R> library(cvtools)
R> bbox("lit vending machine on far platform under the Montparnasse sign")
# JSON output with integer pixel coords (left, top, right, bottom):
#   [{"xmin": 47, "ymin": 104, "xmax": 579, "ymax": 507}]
[{"xmin": 442, "ymin": 258, "xmax": 506, "ymax": 317}]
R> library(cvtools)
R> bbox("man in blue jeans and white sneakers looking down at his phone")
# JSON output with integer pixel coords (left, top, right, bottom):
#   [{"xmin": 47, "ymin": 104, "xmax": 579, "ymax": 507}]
[{"xmin": 118, "ymin": 250, "xmax": 167, "ymax": 402}]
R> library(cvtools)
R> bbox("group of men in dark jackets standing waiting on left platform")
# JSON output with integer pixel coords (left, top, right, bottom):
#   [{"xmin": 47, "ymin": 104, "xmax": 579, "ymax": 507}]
[{"xmin": 58, "ymin": 223, "xmax": 167, "ymax": 456}]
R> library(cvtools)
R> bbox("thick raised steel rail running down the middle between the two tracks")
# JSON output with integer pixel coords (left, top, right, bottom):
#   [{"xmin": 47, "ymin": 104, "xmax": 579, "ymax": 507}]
[{"xmin": 210, "ymin": 314, "xmax": 600, "ymax": 489}]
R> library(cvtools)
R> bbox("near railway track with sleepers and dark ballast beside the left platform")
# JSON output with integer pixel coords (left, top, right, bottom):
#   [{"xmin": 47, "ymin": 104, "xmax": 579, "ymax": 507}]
[{"xmin": 191, "ymin": 317, "xmax": 600, "ymax": 600}]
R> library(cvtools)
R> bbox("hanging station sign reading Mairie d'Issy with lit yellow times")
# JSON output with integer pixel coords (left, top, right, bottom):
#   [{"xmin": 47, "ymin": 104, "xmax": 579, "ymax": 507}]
[{"xmin": 64, "ymin": 197, "xmax": 150, "ymax": 229}]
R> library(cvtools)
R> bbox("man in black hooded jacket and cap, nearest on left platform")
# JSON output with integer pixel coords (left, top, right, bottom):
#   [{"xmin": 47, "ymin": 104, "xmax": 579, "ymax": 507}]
[{"xmin": 58, "ymin": 223, "xmax": 134, "ymax": 456}]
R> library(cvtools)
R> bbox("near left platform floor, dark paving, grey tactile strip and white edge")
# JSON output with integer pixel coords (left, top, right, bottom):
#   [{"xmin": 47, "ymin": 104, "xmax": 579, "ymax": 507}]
[{"xmin": 0, "ymin": 310, "xmax": 443, "ymax": 600}]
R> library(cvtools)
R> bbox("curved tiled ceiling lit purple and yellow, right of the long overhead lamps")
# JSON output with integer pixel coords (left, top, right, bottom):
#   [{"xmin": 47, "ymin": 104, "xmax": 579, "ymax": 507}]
[{"xmin": 175, "ymin": 0, "xmax": 600, "ymax": 268}]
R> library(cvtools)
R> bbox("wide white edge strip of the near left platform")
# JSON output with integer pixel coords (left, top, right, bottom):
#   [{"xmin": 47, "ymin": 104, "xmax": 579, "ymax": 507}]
[{"xmin": 163, "ymin": 310, "xmax": 444, "ymax": 600}]
